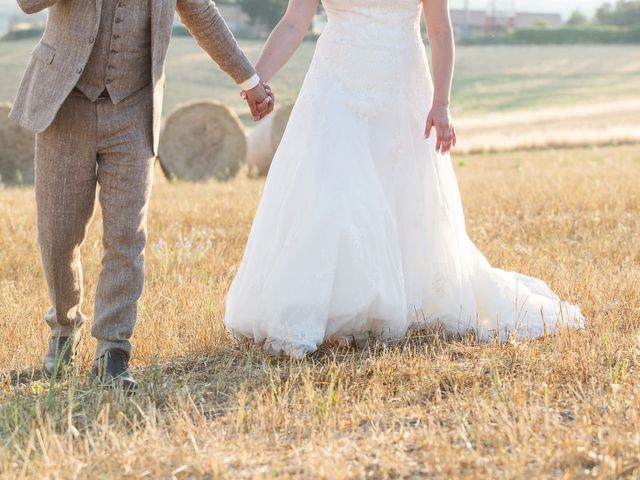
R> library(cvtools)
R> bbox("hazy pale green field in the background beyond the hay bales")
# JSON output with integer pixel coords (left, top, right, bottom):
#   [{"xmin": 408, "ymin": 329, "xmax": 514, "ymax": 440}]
[{"xmin": 0, "ymin": 37, "xmax": 640, "ymax": 124}]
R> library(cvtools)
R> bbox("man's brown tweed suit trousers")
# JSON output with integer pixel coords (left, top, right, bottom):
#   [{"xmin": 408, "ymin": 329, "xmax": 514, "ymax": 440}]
[{"xmin": 35, "ymin": 85, "xmax": 155, "ymax": 357}]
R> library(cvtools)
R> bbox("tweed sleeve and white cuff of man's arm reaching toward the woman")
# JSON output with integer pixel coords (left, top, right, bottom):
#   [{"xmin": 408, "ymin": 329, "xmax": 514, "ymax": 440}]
[{"xmin": 175, "ymin": 0, "xmax": 257, "ymax": 89}]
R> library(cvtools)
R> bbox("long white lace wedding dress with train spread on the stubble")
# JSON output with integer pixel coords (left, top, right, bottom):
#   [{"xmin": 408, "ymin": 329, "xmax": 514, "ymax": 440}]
[{"xmin": 225, "ymin": 0, "xmax": 584, "ymax": 356}]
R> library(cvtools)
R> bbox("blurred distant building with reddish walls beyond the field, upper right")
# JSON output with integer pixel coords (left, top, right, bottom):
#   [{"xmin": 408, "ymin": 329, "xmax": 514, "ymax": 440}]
[{"xmin": 451, "ymin": 9, "xmax": 564, "ymax": 37}]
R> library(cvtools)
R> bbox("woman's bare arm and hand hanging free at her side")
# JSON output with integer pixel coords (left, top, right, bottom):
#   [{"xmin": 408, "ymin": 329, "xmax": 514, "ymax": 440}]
[{"xmin": 422, "ymin": 0, "xmax": 456, "ymax": 153}]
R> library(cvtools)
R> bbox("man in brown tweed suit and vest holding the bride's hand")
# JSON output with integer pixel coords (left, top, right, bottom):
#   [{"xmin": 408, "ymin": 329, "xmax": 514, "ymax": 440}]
[{"xmin": 10, "ymin": 0, "xmax": 273, "ymax": 390}]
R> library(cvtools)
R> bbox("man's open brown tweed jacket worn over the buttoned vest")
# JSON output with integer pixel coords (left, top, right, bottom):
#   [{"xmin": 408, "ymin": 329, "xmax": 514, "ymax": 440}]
[{"xmin": 10, "ymin": 0, "xmax": 255, "ymax": 153}]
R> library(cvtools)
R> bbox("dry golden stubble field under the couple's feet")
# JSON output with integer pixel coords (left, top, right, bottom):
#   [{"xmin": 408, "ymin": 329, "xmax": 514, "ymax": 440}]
[{"xmin": 0, "ymin": 146, "xmax": 640, "ymax": 479}]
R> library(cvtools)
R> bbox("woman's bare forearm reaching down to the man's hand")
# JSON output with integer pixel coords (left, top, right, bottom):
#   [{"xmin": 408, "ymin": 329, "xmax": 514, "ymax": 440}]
[{"xmin": 256, "ymin": 0, "xmax": 320, "ymax": 83}]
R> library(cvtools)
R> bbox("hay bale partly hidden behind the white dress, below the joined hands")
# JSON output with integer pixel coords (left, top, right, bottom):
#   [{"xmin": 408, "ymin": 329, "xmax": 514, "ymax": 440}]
[{"xmin": 247, "ymin": 104, "xmax": 293, "ymax": 175}]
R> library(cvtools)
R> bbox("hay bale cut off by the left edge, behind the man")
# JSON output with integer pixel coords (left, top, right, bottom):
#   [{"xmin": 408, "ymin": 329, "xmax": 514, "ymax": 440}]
[{"xmin": 0, "ymin": 103, "xmax": 35, "ymax": 185}]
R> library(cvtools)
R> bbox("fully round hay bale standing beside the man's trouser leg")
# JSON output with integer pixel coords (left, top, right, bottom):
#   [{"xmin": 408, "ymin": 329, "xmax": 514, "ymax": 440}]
[{"xmin": 159, "ymin": 100, "xmax": 247, "ymax": 181}]
